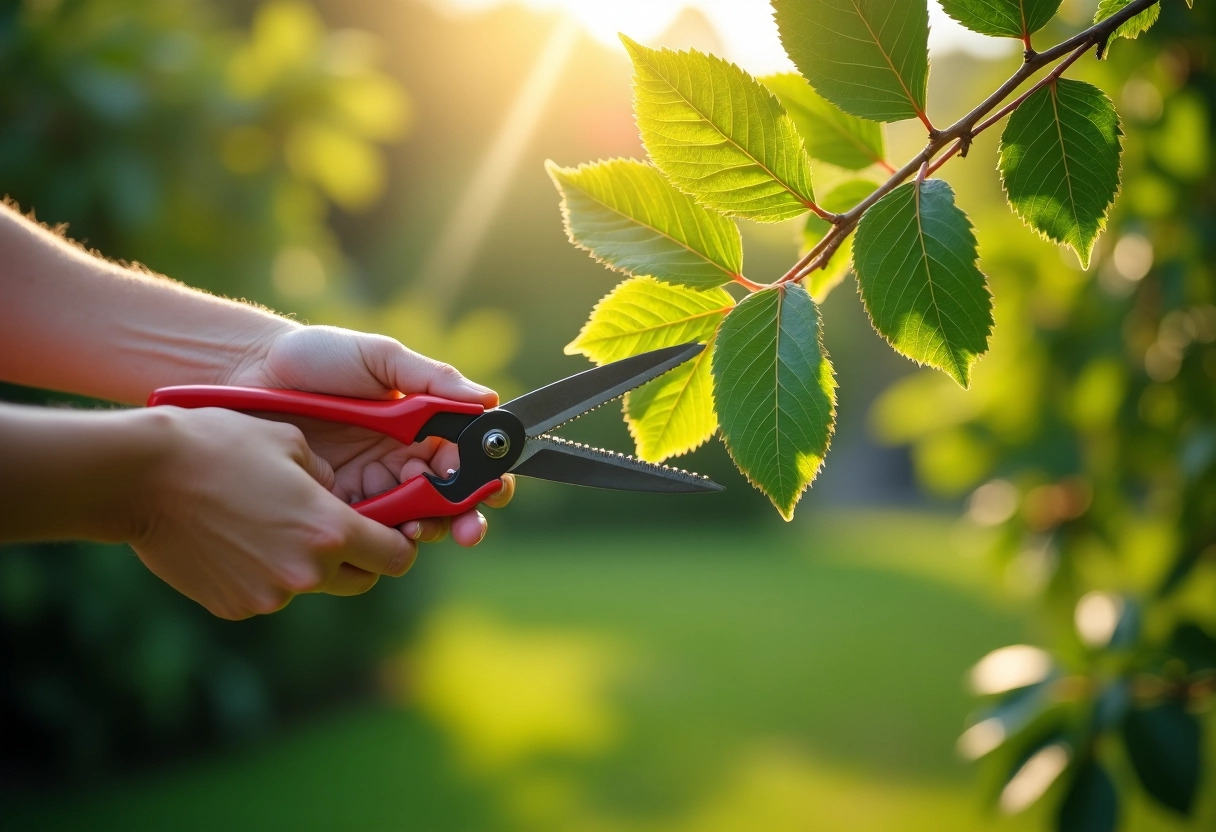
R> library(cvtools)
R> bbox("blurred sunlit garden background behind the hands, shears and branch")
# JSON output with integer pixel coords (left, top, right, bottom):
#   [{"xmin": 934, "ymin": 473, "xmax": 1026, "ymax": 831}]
[{"xmin": 0, "ymin": 0, "xmax": 1216, "ymax": 832}]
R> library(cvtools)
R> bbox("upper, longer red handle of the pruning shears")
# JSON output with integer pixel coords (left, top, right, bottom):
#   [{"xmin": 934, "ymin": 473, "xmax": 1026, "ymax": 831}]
[{"xmin": 148, "ymin": 384, "xmax": 485, "ymax": 445}]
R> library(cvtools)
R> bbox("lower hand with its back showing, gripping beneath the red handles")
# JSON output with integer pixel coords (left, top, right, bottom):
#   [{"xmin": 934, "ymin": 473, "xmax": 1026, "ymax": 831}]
[{"xmin": 134, "ymin": 407, "xmax": 417, "ymax": 620}]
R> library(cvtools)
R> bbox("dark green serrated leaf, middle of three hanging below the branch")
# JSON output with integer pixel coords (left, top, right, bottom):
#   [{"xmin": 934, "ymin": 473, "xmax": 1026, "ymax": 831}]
[{"xmin": 852, "ymin": 179, "xmax": 992, "ymax": 387}]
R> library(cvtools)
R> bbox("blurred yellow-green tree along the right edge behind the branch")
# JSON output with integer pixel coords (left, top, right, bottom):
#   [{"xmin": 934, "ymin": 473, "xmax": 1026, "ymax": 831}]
[{"xmin": 873, "ymin": 2, "xmax": 1216, "ymax": 830}]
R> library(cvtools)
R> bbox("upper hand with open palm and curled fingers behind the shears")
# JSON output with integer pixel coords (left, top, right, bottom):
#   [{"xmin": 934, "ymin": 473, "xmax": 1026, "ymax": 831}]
[{"xmin": 225, "ymin": 326, "xmax": 514, "ymax": 546}]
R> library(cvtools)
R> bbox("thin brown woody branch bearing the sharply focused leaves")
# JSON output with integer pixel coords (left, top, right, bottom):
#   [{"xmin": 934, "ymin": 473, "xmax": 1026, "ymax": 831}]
[{"xmin": 763, "ymin": 0, "xmax": 1161, "ymax": 291}]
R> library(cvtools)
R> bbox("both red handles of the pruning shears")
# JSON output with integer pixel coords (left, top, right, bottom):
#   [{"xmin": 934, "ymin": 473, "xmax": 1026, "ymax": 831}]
[{"xmin": 148, "ymin": 384, "xmax": 491, "ymax": 525}]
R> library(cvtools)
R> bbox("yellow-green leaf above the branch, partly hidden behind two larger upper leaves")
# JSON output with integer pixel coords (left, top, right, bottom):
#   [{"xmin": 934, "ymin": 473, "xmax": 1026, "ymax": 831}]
[{"xmin": 760, "ymin": 72, "xmax": 886, "ymax": 170}]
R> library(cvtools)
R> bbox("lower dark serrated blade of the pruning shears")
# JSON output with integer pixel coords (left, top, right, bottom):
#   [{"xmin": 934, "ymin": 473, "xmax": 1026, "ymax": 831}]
[{"xmin": 511, "ymin": 437, "xmax": 722, "ymax": 494}]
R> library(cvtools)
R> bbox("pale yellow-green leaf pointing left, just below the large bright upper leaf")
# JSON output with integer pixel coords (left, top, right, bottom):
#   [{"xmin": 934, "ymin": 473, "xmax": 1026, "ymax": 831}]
[{"xmin": 545, "ymin": 159, "xmax": 743, "ymax": 287}]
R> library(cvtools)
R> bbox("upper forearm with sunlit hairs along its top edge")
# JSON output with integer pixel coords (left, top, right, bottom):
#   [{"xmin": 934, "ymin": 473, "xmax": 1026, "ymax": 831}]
[{"xmin": 0, "ymin": 206, "xmax": 298, "ymax": 404}]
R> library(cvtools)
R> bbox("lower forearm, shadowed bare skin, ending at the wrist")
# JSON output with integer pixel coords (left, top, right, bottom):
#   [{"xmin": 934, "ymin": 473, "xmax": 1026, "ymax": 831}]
[{"xmin": 0, "ymin": 404, "xmax": 170, "ymax": 543}]
